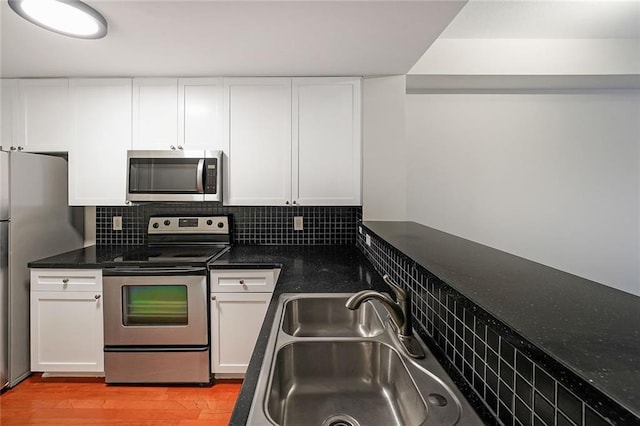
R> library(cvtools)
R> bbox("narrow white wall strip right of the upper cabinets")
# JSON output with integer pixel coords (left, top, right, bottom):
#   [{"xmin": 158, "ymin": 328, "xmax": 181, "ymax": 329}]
[{"xmin": 362, "ymin": 75, "xmax": 407, "ymax": 220}]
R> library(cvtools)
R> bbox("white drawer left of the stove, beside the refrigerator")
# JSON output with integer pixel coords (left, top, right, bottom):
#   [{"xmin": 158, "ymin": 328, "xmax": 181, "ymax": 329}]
[{"xmin": 31, "ymin": 269, "xmax": 102, "ymax": 292}]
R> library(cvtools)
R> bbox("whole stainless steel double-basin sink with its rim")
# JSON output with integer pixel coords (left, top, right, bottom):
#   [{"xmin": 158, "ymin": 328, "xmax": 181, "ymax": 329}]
[{"xmin": 248, "ymin": 293, "xmax": 482, "ymax": 426}]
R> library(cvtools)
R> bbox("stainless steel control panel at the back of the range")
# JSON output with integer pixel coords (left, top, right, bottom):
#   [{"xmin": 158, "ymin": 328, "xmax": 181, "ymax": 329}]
[{"xmin": 147, "ymin": 216, "xmax": 229, "ymax": 234}]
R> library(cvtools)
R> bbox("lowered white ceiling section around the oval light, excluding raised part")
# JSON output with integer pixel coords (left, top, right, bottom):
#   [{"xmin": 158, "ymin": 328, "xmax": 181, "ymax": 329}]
[{"xmin": 0, "ymin": 0, "xmax": 466, "ymax": 78}]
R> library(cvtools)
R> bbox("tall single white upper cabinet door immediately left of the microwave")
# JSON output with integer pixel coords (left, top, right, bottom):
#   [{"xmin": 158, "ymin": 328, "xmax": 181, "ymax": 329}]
[{"xmin": 69, "ymin": 78, "xmax": 131, "ymax": 206}]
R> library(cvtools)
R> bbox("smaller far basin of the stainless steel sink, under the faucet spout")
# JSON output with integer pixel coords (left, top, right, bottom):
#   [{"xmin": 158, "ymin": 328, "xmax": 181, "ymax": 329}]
[{"xmin": 282, "ymin": 294, "xmax": 384, "ymax": 337}]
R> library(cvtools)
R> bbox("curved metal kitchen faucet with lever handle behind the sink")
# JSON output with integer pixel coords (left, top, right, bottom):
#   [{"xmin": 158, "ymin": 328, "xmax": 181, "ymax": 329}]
[{"xmin": 345, "ymin": 274, "xmax": 424, "ymax": 358}]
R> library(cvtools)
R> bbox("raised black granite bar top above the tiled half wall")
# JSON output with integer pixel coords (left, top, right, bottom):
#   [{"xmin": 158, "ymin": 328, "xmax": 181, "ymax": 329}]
[{"xmin": 363, "ymin": 221, "xmax": 640, "ymax": 416}]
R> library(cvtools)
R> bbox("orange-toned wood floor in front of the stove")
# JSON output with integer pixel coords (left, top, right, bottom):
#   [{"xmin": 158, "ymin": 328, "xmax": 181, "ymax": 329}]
[{"xmin": 0, "ymin": 374, "xmax": 242, "ymax": 426}]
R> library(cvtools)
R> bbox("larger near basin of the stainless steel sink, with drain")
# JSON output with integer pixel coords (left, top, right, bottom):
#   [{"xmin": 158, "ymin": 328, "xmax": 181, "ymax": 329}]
[{"xmin": 267, "ymin": 341, "xmax": 427, "ymax": 425}]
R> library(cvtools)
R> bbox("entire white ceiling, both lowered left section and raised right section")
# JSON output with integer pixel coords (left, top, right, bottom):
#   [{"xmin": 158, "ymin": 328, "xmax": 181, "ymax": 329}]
[{"xmin": 0, "ymin": 0, "xmax": 640, "ymax": 77}]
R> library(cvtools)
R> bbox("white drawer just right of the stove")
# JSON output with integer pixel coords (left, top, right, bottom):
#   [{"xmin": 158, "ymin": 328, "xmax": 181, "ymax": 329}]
[{"xmin": 211, "ymin": 269, "xmax": 280, "ymax": 293}]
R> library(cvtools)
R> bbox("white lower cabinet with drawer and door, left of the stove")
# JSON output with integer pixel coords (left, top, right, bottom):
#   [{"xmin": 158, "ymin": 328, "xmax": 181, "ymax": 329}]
[{"xmin": 30, "ymin": 269, "xmax": 104, "ymax": 373}]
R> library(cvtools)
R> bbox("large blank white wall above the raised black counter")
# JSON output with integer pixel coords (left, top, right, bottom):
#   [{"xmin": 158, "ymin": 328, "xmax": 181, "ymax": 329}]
[{"xmin": 406, "ymin": 91, "xmax": 640, "ymax": 295}]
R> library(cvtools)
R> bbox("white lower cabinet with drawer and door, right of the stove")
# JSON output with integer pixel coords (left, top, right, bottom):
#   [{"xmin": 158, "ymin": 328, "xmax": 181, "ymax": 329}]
[{"xmin": 211, "ymin": 269, "xmax": 280, "ymax": 377}]
